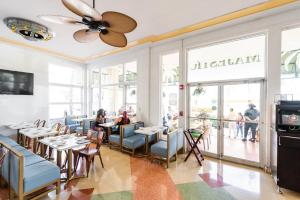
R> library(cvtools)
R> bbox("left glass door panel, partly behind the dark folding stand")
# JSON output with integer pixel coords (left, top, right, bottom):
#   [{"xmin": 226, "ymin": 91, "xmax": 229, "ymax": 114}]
[{"xmin": 189, "ymin": 85, "xmax": 219, "ymax": 155}]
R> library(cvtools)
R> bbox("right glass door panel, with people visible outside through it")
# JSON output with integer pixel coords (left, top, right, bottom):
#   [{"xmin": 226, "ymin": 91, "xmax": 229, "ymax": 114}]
[{"xmin": 221, "ymin": 83, "xmax": 261, "ymax": 162}]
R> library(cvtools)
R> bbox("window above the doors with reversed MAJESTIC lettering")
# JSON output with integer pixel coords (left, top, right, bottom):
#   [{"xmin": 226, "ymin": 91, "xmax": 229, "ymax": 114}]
[{"xmin": 187, "ymin": 35, "xmax": 266, "ymax": 82}]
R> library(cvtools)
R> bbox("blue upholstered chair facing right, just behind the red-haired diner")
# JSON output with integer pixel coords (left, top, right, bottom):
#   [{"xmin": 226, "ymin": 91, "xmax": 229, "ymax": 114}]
[{"xmin": 121, "ymin": 124, "xmax": 145, "ymax": 155}]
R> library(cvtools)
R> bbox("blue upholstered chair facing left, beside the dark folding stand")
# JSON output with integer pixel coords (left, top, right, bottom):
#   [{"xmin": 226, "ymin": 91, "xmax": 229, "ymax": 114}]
[{"xmin": 150, "ymin": 129, "xmax": 184, "ymax": 168}]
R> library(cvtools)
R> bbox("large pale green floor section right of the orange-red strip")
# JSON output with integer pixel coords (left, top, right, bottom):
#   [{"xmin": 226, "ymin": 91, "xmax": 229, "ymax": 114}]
[{"xmin": 176, "ymin": 182, "xmax": 235, "ymax": 200}]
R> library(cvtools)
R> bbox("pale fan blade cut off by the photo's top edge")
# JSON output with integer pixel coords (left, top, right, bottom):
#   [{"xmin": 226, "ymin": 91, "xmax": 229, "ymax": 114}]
[{"xmin": 62, "ymin": 0, "xmax": 101, "ymax": 21}]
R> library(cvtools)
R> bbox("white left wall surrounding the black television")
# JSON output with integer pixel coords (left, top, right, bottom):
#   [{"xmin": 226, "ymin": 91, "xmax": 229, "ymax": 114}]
[{"xmin": 0, "ymin": 44, "xmax": 84, "ymax": 126}]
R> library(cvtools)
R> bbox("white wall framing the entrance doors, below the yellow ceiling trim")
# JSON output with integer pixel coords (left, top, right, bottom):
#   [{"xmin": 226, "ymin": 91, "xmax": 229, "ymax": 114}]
[{"xmin": 89, "ymin": 9, "xmax": 300, "ymax": 166}]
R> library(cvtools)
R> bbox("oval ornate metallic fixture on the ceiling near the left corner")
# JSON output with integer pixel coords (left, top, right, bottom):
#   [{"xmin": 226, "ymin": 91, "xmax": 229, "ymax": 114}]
[{"xmin": 3, "ymin": 17, "xmax": 53, "ymax": 41}]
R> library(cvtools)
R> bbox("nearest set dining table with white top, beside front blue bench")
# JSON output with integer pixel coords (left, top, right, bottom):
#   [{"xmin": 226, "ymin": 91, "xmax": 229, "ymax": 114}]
[{"xmin": 39, "ymin": 134, "xmax": 91, "ymax": 185}]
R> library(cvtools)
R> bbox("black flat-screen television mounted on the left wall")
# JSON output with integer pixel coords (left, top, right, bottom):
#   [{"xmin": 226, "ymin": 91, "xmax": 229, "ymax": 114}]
[{"xmin": 0, "ymin": 69, "xmax": 34, "ymax": 95}]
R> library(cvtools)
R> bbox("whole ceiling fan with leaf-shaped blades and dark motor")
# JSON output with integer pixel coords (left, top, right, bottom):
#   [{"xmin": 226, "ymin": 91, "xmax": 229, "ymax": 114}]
[{"xmin": 38, "ymin": 0, "xmax": 137, "ymax": 47}]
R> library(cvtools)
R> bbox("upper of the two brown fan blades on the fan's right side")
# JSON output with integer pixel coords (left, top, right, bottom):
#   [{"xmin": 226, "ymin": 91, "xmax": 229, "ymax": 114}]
[{"xmin": 102, "ymin": 11, "xmax": 137, "ymax": 33}]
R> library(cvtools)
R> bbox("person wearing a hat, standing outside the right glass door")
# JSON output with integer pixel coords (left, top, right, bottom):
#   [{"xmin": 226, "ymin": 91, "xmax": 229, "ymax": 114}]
[{"xmin": 242, "ymin": 103, "xmax": 259, "ymax": 142}]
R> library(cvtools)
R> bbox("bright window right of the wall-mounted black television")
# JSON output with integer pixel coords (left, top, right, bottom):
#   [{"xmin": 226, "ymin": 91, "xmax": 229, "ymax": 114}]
[{"xmin": 48, "ymin": 64, "xmax": 84, "ymax": 119}]
